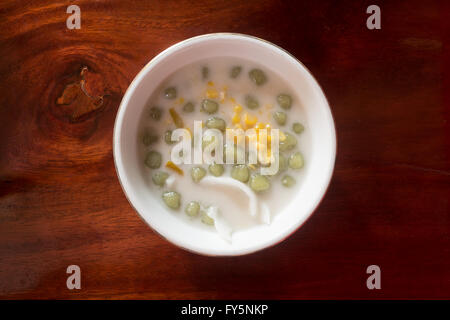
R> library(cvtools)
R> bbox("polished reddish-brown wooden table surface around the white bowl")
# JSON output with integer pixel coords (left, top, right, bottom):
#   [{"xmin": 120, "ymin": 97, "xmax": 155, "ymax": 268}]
[{"xmin": 0, "ymin": 0, "xmax": 450, "ymax": 299}]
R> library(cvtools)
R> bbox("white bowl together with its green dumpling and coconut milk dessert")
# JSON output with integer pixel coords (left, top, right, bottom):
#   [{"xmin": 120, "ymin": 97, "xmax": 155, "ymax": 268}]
[{"xmin": 113, "ymin": 34, "xmax": 336, "ymax": 255}]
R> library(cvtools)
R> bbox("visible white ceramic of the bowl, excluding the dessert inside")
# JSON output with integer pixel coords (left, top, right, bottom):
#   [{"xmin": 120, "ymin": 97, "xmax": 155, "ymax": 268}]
[{"xmin": 113, "ymin": 33, "xmax": 336, "ymax": 256}]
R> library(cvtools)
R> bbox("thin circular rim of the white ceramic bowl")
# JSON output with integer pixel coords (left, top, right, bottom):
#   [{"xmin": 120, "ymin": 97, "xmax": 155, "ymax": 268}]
[{"xmin": 112, "ymin": 32, "xmax": 337, "ymax": 257}]
